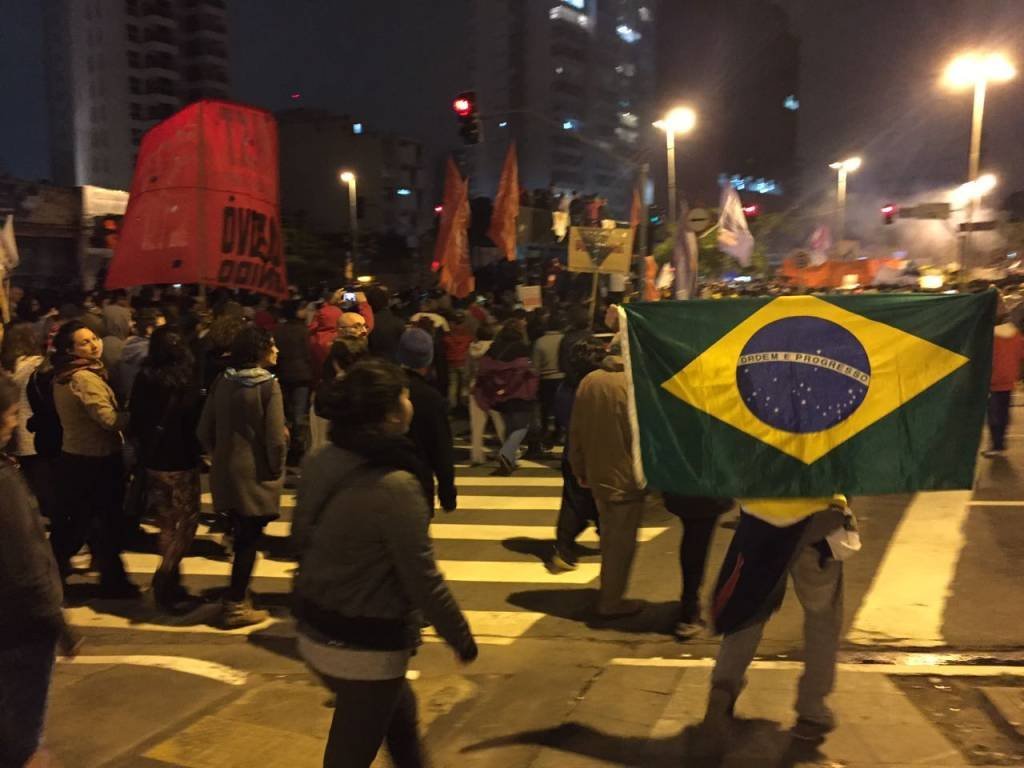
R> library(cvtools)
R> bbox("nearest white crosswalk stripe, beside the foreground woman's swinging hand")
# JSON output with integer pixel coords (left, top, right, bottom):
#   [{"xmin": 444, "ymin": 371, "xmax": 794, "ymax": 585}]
[{"xmin": 65, "ymin": 604, "xmax": 545, "ymax": 645}]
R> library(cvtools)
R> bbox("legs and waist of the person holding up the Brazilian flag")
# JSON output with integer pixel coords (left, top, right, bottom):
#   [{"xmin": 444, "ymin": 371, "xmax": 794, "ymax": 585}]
[{"xmin": 705, "ymin": 496, "xmax": 860, "ymax": 741}]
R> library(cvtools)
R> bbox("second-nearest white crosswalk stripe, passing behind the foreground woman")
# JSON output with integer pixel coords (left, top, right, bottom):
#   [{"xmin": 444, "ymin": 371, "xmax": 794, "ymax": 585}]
[{"xmin": 124, "ymin": 552, "xmax": 600, "ymax": 584}]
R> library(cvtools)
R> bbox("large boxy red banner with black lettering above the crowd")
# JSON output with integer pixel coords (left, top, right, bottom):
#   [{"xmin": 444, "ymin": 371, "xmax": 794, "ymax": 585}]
[{"xmin": 106, "ymin": 100, "xmax": 288, "ymax": 297}]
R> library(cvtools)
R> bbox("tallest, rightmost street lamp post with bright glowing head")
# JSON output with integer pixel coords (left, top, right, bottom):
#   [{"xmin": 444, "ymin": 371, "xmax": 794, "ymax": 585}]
[{"xmin": 943, "ymin": 52, "xmax": 1017, "ymax": 286}]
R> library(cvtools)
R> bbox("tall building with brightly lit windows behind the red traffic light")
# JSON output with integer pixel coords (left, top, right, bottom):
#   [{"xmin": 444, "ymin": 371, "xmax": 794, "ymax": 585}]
[{"xmin": 464, "ymin": 0, "xmax": 658, "ymax": 217}]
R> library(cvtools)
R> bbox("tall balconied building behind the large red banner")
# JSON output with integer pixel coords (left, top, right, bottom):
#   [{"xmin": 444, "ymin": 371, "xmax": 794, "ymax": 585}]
[{"xmin": 44, "ymin": 0, "xmax": 228, "ymax": 188}]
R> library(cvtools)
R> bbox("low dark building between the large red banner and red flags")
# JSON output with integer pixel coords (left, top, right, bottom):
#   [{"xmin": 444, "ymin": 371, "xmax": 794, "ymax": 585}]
[{"xmin": 276, "ymin": 109, "xmax": 429, "ymax": 246}]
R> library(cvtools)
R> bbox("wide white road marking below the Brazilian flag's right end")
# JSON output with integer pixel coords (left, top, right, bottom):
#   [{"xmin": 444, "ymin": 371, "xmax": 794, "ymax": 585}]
[{"xmin": 847, "ymin": 490, "xmax": 971, "ymax": 647}]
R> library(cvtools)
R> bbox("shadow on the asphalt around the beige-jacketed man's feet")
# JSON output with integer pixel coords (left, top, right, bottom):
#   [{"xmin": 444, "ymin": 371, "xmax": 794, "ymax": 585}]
[{"xmin": 506, "ymin": 589, "xmax": 679, "ymax": 635}]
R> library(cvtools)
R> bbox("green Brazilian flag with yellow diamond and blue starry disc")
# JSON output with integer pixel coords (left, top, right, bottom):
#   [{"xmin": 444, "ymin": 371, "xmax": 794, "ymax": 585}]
[{"xmin": 624, "ymin": 291, "xmax": 996, "ymax": 498}]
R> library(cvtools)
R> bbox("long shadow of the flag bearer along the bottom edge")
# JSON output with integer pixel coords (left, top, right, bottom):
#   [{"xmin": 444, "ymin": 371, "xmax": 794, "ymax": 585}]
[{"xmin": 462, "ymin": 720, "xmax": 825, "ymax": 768}]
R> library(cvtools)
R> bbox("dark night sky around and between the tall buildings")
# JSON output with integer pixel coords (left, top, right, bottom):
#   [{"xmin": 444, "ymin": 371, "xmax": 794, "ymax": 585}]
[{"xmin": 6, "ymin": 0, "xmax": 1024, "ymax": 206}]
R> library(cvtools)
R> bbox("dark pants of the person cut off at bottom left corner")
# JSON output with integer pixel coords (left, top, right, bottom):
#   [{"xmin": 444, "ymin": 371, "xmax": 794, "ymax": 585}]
[{"xmin": 0, "ymin": 633, "xmax": 56, "ymax": 768}]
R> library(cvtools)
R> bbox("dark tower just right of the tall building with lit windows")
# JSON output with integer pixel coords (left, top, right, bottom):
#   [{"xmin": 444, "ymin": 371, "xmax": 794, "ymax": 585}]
[{"xmin": 657, "ymin": 0, "xmax": 801, "ymax": 208}]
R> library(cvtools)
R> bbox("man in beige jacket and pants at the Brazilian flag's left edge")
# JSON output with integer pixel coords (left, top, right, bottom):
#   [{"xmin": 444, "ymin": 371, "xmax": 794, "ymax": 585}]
[{"xmin": 569, "ymin": 346, "xmax": 646, "ymax": 618}]
